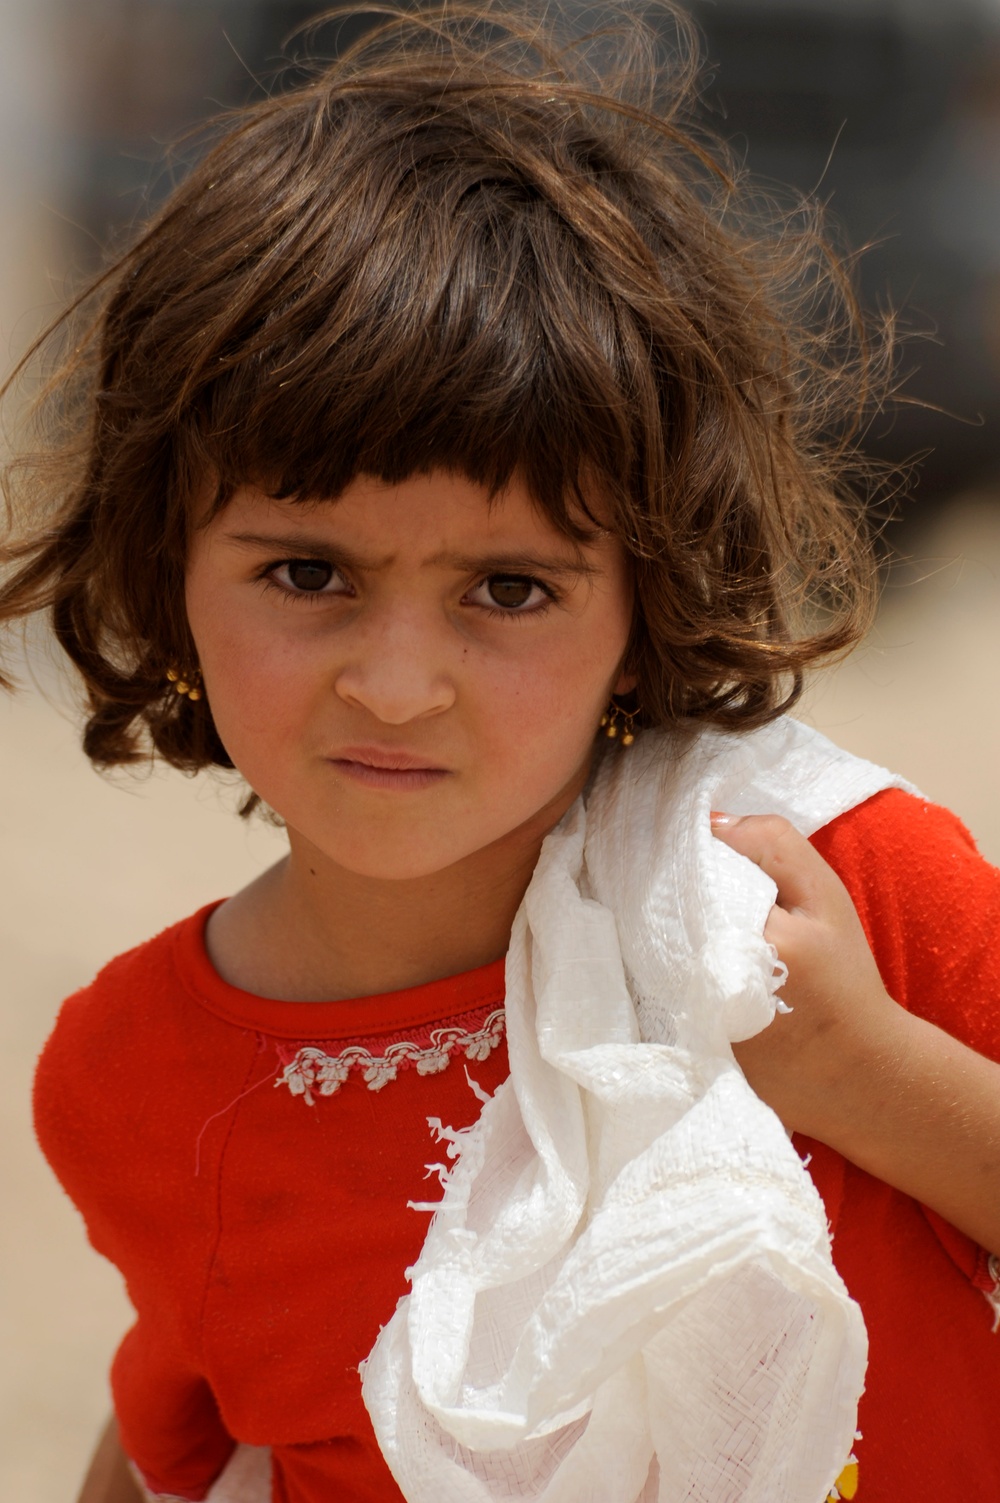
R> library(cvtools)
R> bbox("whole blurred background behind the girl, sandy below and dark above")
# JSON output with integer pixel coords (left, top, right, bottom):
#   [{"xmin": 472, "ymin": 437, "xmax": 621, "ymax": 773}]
[{"xmin": 0, "ymin": 0, "xmax": 1000, "ymax": 1503}]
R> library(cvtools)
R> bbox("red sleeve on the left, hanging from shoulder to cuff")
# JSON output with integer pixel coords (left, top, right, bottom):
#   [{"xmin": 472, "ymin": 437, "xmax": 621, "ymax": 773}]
[{"xmin": 35, "ymin": 941, "xmax": 235, "ymax": 1500}]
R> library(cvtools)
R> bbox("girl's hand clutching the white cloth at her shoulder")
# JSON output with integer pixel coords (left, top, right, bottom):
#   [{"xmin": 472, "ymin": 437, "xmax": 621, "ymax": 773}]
[{"xmin": 711, "ymin": 815, "xmax": 905, "ymax": 1144}]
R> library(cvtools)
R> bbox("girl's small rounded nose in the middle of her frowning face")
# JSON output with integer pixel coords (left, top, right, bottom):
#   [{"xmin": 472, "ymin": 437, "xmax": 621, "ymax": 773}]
[{"xmin": 335, "ymin": 607, "xmax": 456, "ymax": 726}]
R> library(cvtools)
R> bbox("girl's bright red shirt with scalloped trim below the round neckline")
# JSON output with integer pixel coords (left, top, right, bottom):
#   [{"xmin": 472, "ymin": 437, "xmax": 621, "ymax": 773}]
[{"xmin": 36, "ymin": 791, "xmax": 1000, "ymax": 1503}]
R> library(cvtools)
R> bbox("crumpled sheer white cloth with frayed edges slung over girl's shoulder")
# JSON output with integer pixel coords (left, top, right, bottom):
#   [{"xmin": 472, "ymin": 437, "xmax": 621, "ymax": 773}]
[{"xmin": 364, "ymin": 720, "xmax": 907, "ymax": 1503}]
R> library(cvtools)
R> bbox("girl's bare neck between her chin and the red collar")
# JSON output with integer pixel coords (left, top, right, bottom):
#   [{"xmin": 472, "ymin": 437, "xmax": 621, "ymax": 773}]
[{"xmin": 208, "ymin": 800, "xmax": 570, "ymax": 1001}]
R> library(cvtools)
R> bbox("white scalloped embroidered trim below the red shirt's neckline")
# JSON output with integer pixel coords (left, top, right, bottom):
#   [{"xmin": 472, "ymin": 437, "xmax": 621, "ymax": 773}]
[{"xmin": 274, "ymin": 1007, "xmax": 504, "ymax": 1106}]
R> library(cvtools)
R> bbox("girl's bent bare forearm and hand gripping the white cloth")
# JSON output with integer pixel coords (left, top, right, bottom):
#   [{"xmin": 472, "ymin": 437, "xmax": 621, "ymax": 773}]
[{"xmin": 713, "ymin": 816, "xmax": 1000, "ymax": 1250}]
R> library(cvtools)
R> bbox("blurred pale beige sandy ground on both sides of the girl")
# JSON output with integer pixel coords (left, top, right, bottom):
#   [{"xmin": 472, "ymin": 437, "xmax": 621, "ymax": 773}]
[{"xmin": 0, "ymin": 497, "xmax": 1000, "ymax": 1503}]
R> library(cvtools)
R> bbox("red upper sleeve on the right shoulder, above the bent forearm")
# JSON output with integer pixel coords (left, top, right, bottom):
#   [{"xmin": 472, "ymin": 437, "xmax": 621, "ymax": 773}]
[{"xmin": 812, "ymin": 788, "xmax": 1000, "ymax": 1058}]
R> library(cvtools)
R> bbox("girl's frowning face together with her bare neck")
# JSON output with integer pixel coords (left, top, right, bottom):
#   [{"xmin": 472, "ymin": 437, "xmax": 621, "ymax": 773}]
[{"xmin": 186, "ymin": 473, "xmax": 633, "ymax": 1001}]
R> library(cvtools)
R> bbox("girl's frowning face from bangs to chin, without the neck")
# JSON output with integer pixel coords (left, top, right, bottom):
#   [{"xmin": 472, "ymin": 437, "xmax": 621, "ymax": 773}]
[{"xmin": 186, "ymin": 472, "xmax": 633, "ymax": 879}]
